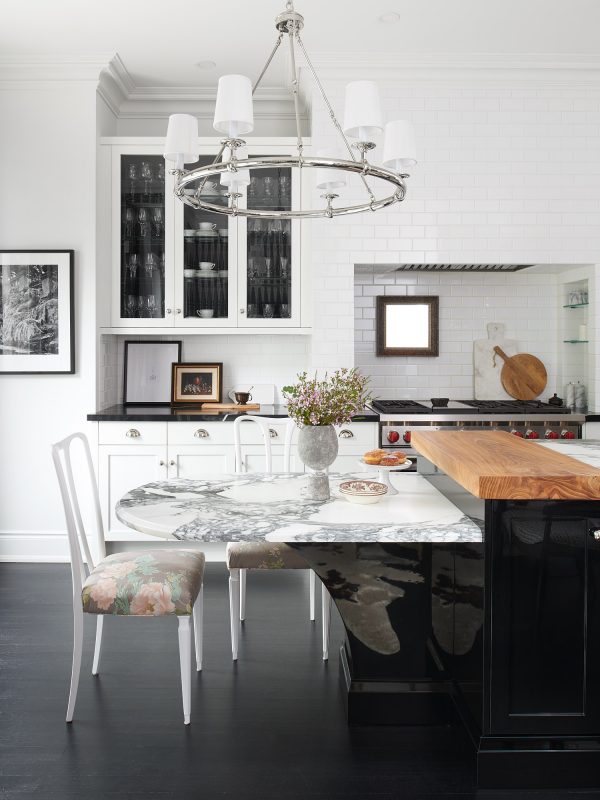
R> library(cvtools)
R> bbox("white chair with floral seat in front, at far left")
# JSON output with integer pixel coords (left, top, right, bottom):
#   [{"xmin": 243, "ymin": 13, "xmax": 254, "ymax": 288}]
[{"xmin": 52, "ymin": 433, "xmax": 204, "ymax": 725}]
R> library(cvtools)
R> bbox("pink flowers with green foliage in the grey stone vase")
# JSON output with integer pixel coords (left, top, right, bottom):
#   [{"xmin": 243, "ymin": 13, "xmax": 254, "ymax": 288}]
[{"xmin": 283, "ymin": 367, "xmax": 370, "ymax": 425}]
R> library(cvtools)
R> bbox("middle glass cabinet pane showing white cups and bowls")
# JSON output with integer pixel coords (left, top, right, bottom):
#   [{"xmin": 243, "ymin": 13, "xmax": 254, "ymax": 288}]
[{"xmin": 176, "ymin": 156, "xmax": 235, "ymax": 327}]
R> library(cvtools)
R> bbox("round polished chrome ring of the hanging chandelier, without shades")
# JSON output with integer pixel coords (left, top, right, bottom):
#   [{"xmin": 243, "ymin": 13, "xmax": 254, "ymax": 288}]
[{"xmin": 174, "ymin": 155, "xmax": 408, "ymax": 219}]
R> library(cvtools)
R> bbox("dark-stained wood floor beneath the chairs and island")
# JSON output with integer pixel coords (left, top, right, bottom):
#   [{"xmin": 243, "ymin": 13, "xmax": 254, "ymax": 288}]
[{"xmin": 0, "ymin": 564, "xmax": 600, "ymax": 800}]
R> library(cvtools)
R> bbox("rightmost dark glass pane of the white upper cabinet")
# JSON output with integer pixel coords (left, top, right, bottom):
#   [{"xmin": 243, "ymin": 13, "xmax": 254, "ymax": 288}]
[{"xmin": 245, "ymin": 161, "xmax": 297, "ymax": 325}]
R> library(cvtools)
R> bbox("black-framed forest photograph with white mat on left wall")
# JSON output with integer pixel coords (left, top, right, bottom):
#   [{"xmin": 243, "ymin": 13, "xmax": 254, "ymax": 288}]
[{"xmin": 0, "ymin": 250, "xmax": 75, "ymax": 374}]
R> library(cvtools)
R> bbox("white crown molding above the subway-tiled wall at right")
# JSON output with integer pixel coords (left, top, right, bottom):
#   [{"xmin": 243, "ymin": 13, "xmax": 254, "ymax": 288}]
[{"xmin": 303, "ymin": 52, "xmax": 600, "ymax": 88}]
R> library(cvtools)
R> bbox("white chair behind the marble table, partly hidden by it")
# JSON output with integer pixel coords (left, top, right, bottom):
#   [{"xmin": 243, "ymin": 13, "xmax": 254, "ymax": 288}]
[{"xmin": 227, "ymin": 414, "xmax": 331, "ymax": 661}]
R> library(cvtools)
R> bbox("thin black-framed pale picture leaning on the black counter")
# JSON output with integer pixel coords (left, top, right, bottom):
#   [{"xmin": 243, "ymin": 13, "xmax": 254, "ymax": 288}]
[{"xmin": 123, "ymin": 341, "xmax": 181, "ymax": 406}]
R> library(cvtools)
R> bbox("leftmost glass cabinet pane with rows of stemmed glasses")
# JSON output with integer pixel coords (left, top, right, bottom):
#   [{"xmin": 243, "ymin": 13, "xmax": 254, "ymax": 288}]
[{"xmin": 120, "ymin": 155, "xmax": 165, "ymax": 325}]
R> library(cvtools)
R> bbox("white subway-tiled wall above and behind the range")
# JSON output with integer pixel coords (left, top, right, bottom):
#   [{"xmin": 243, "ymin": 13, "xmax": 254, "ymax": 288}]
[{"xmin": 309, "ymin": 68, "xmax": 600, "ymax": 390}]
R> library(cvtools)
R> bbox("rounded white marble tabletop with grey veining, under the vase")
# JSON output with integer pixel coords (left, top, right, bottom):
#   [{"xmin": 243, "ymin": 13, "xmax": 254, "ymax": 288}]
[{"xmin": 116, "ymin": 473, "xmax": 482, "ymax": 543}]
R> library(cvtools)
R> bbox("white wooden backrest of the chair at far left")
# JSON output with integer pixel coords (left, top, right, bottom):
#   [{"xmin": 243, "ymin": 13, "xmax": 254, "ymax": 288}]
[{"xmin": 52, "ymin": 433, "xmax": 106, "ymax": 595}]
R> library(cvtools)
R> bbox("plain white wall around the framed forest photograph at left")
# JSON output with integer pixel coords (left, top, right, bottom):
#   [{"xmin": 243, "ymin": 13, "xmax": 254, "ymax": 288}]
[{"xmin": 0, "ymin": 75, "xmax": 96, "ymax": 559}]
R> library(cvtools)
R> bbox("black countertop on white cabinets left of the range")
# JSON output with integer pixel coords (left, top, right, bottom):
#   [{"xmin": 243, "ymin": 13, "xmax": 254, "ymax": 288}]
[{"xmin": 87, "ymin": 405, "xmax": 379, "ymax": 422}]
